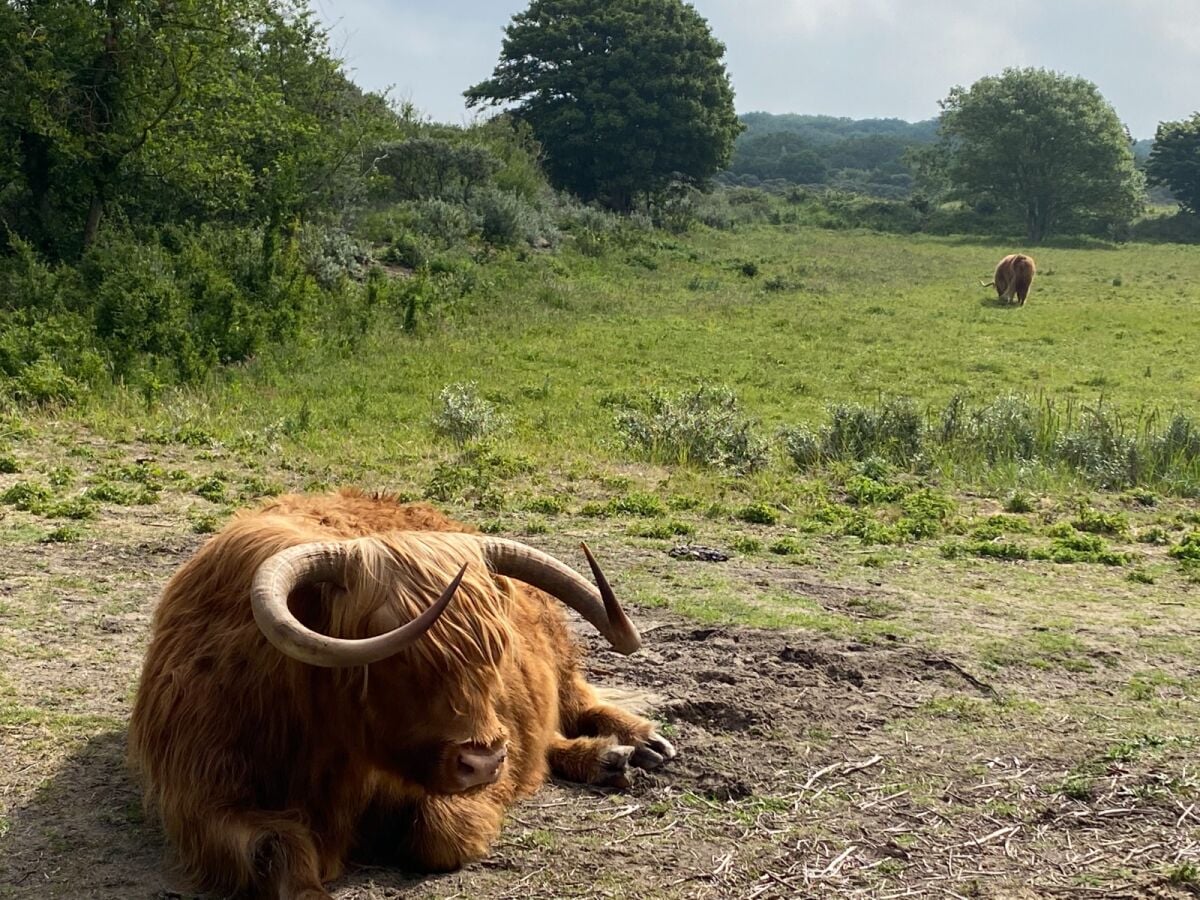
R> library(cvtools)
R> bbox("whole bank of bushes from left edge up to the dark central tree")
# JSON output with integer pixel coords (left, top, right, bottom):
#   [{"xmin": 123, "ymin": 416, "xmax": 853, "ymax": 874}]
[{"xmin": 0, "ymin": 111, "xmax": 578, "ymax": 403}]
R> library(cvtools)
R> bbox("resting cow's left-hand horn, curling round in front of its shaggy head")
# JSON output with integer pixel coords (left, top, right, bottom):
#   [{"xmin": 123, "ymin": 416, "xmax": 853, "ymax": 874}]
[{"xmin": 250, "ymin": 541, "xmax": 467, "ymax": 667}]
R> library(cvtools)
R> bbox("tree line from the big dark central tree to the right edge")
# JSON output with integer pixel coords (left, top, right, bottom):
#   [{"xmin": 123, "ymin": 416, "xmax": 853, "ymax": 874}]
[{"xmin": 466, "ymin": 0, "xmax": 1200, "ymax": 242}]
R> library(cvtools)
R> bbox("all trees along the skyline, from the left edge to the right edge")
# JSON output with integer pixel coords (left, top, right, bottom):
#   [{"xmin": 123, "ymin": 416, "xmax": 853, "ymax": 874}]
[{"xmin": 7, "ymin": 0, "xmax": 1200, "ymax": 258}]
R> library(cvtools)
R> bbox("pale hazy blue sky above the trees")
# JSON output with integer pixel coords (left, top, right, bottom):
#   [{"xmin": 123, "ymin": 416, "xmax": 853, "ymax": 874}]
[{"xmin": 312, "ymin": 0, "xmax": 1200, "ymax": 138}]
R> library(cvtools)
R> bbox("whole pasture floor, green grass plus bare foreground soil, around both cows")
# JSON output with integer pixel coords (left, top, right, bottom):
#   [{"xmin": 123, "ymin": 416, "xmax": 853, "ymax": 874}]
[{"xmin": 0, "ymin": 227, "xmax": 1200, "ymax": 900}]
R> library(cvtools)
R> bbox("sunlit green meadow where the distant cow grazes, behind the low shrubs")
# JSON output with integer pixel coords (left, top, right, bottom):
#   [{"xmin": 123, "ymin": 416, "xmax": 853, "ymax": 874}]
[{"xmin": 79, "ymin": 227, "xmax": 1200, "ymax": 467}]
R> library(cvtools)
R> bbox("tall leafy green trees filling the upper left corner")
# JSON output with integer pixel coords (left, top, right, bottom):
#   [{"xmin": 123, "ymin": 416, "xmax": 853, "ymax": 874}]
[{"xmin": 0, "ymin": 0, "xmax": 389, "ymax": 258}]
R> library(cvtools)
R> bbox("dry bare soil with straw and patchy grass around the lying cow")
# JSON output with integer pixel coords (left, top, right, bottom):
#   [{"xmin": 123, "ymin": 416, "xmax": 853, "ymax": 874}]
[{"xmin": 0, "ymin": 434, "xmax": 1200, "ymax": 900}]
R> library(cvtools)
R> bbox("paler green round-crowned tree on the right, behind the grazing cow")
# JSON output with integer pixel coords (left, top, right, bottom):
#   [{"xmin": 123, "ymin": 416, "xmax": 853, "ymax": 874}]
[{"xmin": 930, "ymin": 68, "xmax": 1144, "ymax": 242}]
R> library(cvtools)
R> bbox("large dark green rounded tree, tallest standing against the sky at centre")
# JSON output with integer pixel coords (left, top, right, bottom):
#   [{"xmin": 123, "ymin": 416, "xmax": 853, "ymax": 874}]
[{"xmin": 466, "ymin": 0, "xmax": 742, "ymax": 210}]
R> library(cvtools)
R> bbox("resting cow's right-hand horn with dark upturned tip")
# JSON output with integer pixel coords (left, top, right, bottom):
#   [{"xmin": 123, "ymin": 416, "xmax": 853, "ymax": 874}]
[{"xmin": 479, "ymin": 538, "xmax": 642, "ymax": 654}]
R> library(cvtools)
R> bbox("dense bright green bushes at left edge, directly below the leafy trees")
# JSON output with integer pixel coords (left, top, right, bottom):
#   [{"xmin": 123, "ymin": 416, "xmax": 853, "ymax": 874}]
[{"xmin": 0, "ymin": 227, "xmax": 322, "ymax": 388}]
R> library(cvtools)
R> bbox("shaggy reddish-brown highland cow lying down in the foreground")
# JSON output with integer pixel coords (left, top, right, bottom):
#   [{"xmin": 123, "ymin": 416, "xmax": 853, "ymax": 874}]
[{"xmin": 130, "ymin": 492, "xmax": 674, "ymax": 900}]
